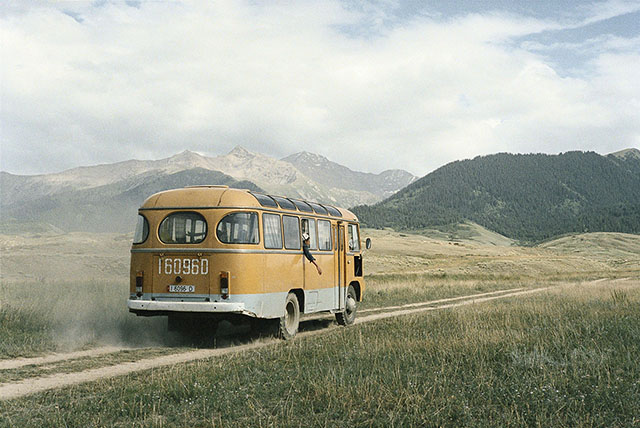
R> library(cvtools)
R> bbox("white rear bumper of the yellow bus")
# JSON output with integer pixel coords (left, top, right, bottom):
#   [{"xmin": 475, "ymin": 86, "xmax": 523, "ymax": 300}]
[{"xmin": 127, "ymin": 300, "xmax": 249, "ymax": 316}]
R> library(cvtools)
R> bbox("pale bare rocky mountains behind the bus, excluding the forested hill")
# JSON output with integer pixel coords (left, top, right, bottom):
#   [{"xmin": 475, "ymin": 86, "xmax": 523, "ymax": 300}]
[{"xmin": 0, "ymin": 147, "xmax": 417, "ymax": 232}]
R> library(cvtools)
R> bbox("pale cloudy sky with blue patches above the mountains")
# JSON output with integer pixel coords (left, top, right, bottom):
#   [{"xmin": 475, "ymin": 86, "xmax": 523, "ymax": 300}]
[{"xmin": 0, "ymin": 0, "xmax": 640, "ymax": 175}]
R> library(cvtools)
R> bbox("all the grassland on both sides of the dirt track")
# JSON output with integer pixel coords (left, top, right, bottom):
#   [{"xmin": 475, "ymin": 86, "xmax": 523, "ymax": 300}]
[{"xmin": 0, "ymin": 231, "xmax": 640, "ymax": 427}]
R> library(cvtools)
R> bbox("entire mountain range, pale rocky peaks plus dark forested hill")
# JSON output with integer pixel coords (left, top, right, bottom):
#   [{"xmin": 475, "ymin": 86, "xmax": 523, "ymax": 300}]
[{"xmin": 0, "ymin": 147, "xmax": 640, "ymax": 242}]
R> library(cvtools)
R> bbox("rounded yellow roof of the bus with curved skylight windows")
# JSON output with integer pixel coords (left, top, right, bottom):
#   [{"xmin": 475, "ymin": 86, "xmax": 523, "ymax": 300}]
[{"xmin": 140, "ymin": 186, "xmax": 358, "ymax": 221}]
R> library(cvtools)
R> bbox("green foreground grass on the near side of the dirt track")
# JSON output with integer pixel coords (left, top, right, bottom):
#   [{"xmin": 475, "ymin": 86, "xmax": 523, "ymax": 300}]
[{"xmin": 0, "ymin": 284, "xmax": 640, "ymax": 427}]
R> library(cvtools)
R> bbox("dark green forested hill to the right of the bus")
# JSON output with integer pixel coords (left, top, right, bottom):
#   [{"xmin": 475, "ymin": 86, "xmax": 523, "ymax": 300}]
[{"xmin": 353, "ymin": 150, "xmax": 640, "ymax": 242}]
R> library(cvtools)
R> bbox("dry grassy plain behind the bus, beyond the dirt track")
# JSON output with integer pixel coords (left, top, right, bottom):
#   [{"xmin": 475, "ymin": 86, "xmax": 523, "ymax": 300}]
[{"xmin": 0, "ymin": 230, "xmax": 640, "ymax": 359}]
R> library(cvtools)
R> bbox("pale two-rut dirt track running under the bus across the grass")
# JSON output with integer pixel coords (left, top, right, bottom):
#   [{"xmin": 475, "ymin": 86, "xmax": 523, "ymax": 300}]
[{"xmin": 0, "ymin": 280, "xmax": 632, "ymax": 400}]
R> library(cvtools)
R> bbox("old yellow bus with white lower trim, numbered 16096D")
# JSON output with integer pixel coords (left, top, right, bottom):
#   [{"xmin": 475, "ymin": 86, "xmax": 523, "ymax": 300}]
[{"xmin": 128, "ymin": 186, "xmax": 370, "ymax": 339}]
